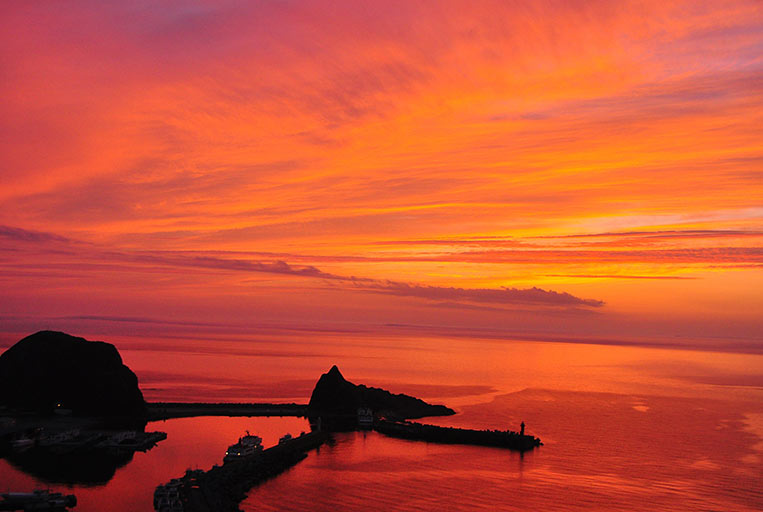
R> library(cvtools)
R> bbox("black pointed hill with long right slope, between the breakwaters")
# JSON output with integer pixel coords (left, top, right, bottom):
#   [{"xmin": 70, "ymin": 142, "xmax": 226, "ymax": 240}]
[{"xmin": 308, "ymin": 365, "xmax": 455, "ymax": 419}]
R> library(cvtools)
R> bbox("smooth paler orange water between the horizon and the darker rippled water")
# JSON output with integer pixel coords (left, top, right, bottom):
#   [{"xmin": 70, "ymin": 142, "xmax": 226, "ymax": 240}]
[{"xmin": 113, "ymin": 337, "xmax": 763, "ymax": 407}]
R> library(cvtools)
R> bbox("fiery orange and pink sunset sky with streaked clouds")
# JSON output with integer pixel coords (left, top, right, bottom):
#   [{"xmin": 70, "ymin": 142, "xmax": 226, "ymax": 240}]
[{"xmin": 0, "ymin": 0, "xmax": 763, "ymax": 352}]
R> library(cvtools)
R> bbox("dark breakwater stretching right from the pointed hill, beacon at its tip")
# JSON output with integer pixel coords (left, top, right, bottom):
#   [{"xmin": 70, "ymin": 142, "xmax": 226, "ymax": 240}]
[{"xmin": 374, "ymin": 419, "xmax": 543, "ymax": 451}]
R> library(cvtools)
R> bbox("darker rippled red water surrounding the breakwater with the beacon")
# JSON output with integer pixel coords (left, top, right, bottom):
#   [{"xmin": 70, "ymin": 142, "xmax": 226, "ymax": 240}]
[{"xmin": 243, "ymin": 389, "xmax": 763, "ymax": 512}]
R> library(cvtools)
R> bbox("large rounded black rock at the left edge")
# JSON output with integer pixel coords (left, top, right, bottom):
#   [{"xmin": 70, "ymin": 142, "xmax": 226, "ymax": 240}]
[{"xmin": 0, "ymin": 331, "xmax": 146, "ymax": 419}]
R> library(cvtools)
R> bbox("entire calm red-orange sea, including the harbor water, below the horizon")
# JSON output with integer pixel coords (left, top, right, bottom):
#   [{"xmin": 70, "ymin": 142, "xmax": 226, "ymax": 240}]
[{"xmin": 0, "ymin": 338, "xmax": 763, "ymax": 512}]
